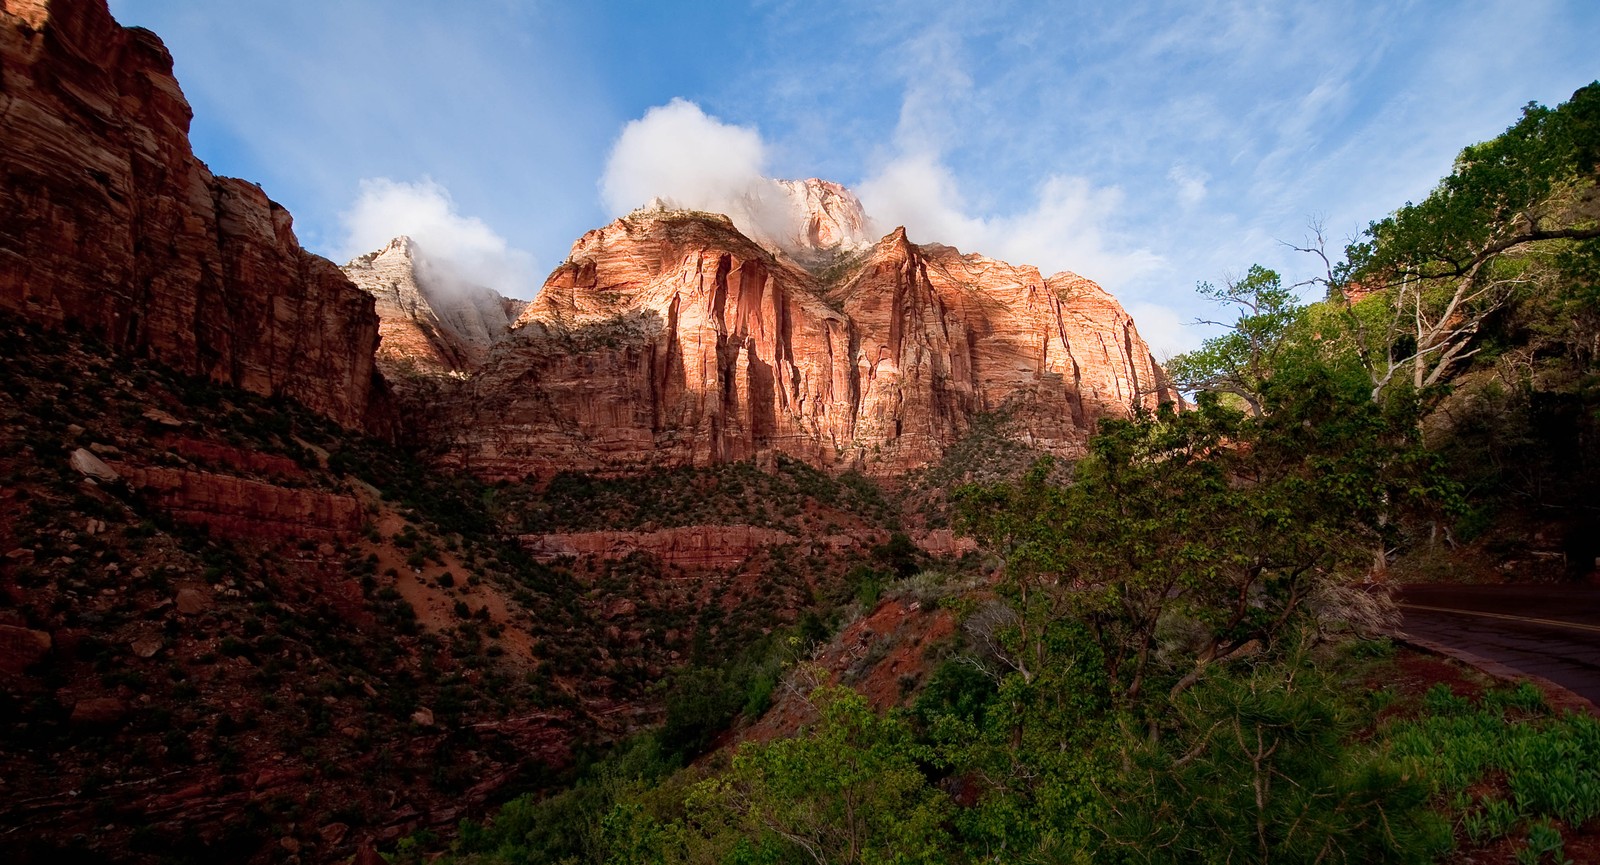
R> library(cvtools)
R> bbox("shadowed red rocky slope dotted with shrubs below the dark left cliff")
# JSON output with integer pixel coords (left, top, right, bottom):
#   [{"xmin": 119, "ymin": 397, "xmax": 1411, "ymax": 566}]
[{"xmin": 0, "ymin": 318, "xmax": 582, "ymax": 863}]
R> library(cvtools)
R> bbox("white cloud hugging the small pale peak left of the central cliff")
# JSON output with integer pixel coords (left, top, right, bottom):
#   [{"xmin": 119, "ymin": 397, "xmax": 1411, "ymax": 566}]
[{"xmin": 341, "ymin": 177, "xmax": 538, "ymax": 297}]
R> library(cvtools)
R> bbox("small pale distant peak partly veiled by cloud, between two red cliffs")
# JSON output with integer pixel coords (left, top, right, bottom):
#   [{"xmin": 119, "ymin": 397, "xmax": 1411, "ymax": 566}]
[{"xmin": 342, "ymin": 237, "xmax": 526, "ymax": 377}]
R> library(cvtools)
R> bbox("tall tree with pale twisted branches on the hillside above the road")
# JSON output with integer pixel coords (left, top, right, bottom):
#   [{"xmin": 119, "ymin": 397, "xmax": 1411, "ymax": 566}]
[{"xmin": 1330, "ymin": 82, "xmax": 1600, "ymax": 400}]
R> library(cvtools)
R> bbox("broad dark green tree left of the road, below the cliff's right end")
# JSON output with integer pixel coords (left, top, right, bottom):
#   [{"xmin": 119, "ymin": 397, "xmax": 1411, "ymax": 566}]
[{"xmin": 960, "ymin": 366, "xmax": 1437, "ymax": 707}]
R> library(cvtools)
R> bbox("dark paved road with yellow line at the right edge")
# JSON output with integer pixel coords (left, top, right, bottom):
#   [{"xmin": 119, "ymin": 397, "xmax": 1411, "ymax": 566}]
[{"xmin": 1395, "ymin": 585, "xmax": 1600, "ymax": 705}]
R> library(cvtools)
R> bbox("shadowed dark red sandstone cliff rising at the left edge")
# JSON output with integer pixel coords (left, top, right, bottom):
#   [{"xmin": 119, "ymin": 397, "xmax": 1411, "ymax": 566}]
[{"xmin": 0, "ymin": 0, "xmax": 378, "ymax": 425}]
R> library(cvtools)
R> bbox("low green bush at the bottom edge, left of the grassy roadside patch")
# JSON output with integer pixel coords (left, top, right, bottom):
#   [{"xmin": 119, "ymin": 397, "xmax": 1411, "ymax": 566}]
[{"xmin": 1099, "ymin": 659, "xmax": 1451, "ymax": 865}]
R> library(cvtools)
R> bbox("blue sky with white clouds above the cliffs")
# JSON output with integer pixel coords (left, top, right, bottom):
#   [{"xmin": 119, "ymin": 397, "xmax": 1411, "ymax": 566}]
[{"xmin": 110, "ymin": 0, "xmax": 1600, "ymax": 358}]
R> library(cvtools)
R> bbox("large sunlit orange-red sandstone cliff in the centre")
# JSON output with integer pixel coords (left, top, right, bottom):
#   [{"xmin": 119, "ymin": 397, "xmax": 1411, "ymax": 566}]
[{"xmin": 456, "ymin": 211, "xmax": 1171, "ymax": 476}]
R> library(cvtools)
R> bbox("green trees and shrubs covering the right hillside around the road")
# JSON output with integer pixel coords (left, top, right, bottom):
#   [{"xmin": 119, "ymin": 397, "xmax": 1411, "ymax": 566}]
[{"xmin": 416, "ymin": 85, "xmax": 1600, "ymax": 863}]
